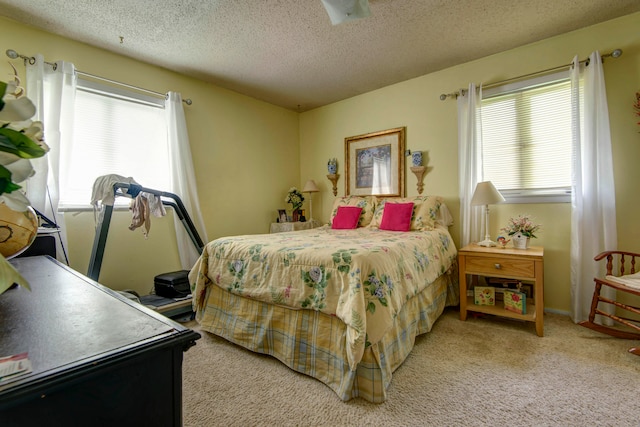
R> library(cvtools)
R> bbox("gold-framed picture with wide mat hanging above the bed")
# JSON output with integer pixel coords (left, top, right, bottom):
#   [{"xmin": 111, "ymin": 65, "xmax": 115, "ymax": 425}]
[{"xmin": 344, "ymin": 127, "xmax": 405, "ymax": 197}]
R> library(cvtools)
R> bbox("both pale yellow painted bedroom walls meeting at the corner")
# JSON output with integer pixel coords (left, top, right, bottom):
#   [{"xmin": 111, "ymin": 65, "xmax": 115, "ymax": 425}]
[{"xmin": 0, "ymin": 14, "xmax": 640, "ymax": 312}]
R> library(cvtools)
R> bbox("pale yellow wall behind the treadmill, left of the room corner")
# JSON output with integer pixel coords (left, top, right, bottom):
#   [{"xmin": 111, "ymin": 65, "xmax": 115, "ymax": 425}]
[{"xmin": 0, "ymin": 17, "xmax": 301, "ymax": 294}]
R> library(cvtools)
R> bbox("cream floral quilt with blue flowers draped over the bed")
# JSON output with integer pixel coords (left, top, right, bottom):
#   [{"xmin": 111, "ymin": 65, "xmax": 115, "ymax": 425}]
[{"xmin": 189, "ymin": 226, "xmax": 457, "ymax": 369}]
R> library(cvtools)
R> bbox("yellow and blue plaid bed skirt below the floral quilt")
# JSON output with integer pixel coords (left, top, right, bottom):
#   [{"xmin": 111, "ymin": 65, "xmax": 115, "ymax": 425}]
[{"xmin": 196, "ymin": 268, "xmax": 459, "ymax": 403}]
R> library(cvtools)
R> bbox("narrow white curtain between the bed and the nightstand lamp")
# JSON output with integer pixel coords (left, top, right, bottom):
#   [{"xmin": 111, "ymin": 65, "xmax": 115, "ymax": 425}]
[{"xmin": 457, "ymin": 83, "xmax": 483, "ymax": 247}]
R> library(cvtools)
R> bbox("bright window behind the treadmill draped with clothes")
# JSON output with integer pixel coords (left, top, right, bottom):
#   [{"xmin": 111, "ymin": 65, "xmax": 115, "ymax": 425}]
[{"xmin": 60, "ymin": 79, "xmax": 170, "ymax": 209}]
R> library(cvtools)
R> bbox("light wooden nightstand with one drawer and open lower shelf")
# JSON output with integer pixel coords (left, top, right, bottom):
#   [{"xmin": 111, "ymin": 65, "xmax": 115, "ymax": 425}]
[{"xmin": 458, "ymin": 244, "xmax": 544, "ymax": 336}]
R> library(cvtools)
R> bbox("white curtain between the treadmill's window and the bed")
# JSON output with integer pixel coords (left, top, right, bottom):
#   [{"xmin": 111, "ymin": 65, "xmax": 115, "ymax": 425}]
[{"xmin": 165, "ymin": 92, "xmax": 209, "ymax": 270}]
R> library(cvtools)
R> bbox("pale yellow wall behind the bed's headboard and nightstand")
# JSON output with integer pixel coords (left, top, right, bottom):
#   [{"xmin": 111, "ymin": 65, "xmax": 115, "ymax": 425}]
[{"xmin": 300, "ymin": 14, "xmax": 640, "ymax": 312}]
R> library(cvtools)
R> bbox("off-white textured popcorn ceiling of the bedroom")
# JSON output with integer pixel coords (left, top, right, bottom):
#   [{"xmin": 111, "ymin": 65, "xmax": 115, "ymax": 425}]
[{"xmin": 0, "ymin": 0, "xmax": 640, "ymax": 111}]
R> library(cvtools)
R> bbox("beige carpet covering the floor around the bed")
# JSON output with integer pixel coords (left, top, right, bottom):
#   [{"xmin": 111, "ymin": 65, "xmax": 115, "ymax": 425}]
[{"xmin": 183, "ymin": 309, "xmax": 640, "ymax": 427}]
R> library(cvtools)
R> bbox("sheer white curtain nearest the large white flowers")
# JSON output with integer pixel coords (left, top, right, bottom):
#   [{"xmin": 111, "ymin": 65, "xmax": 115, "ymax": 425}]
[{"xmin": 26, "ymin": 54, "xmax": 76, "ymax": 262}]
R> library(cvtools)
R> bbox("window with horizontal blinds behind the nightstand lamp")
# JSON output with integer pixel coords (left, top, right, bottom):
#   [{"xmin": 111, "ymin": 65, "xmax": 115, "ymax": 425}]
[{"xmin": 481, "ymin": 72, "xmax": 572, "ymax": 203}]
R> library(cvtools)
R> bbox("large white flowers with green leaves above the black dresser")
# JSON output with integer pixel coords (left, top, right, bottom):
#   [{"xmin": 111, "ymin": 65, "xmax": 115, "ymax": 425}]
[{"xmin": 0, "ymin": 65, "xmax": 48, "ymax": 294}]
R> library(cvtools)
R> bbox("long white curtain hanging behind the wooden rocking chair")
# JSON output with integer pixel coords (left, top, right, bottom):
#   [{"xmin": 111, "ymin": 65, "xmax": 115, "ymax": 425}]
[{"xmin": 571, "ymin": 52, "xmax": 618, "ymax": 323}]
